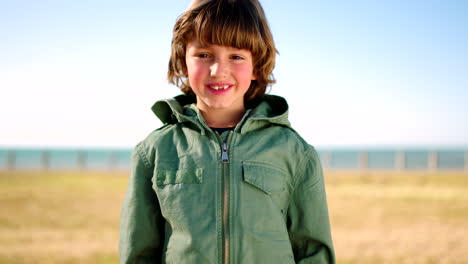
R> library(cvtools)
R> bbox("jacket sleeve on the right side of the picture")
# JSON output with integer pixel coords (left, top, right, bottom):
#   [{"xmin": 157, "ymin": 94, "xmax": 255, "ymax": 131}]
[{"xmin": 288, "ymin": 147, "xmax": 335, "ymax": 264}]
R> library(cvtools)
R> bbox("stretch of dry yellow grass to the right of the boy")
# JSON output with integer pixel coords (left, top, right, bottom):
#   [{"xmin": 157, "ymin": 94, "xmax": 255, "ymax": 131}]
[{"xmin": 327, "ymin": 172, "xmax": 468, "ymax": 264}]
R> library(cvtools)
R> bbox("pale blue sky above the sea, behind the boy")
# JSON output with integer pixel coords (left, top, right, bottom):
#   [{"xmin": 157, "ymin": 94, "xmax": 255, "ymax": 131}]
[{"xmin": 0, "ymin": 0, "xmax": 468, "ymax": 147}]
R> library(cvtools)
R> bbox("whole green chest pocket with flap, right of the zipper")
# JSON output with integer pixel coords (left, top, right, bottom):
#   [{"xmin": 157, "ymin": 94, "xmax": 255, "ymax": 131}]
[{"xmin": 241, "ymin": 161, "xmax": 290, "ymax": 239}]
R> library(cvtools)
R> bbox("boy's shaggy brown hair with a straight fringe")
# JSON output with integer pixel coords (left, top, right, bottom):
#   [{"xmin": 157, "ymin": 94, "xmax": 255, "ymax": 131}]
[{"xmin": 167, "ymin": 0, "xmax": 277, "ymax": 102}]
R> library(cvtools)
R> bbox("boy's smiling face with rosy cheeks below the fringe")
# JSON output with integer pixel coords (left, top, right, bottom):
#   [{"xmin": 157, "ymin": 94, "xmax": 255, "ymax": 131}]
[{"xmin": 185, "ymin": 40, "xmax": 255, "ymax": 114}]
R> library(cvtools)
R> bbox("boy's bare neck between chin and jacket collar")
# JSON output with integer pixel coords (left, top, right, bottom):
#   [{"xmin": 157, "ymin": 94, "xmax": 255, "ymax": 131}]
[{"xmin": 199, "ymin": 105, "xmax": 245, "ymax": 128}]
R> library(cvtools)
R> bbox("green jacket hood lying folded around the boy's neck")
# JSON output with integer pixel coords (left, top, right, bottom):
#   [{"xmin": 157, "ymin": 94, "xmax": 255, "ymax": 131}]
[{"xmin": 151, "ymin": 95, "xmax": 290, "ymax": 132}]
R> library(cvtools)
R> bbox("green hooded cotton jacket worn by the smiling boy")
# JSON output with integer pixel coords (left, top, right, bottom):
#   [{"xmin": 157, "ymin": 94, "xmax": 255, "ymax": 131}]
[{"xmin": 119, "ymin": 95, "xmax": 335, "ymax": 264}]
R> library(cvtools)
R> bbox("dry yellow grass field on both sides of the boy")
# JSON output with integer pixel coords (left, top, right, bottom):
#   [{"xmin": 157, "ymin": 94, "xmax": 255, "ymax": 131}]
[{"xmin": 0, "ymin": 172, "xmax": 468, "ymax": 264}]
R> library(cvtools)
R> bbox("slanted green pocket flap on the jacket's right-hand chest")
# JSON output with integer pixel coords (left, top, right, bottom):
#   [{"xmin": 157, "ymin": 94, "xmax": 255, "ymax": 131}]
[{"xmin": 242, "ymin": 161, "xmax": 286, "ymax": 194}]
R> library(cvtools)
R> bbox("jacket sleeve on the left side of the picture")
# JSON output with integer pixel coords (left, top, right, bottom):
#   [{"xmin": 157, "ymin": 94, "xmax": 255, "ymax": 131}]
[{"xmin": 119, "ymin": 143, "xmax": 164, "ymax": 264}]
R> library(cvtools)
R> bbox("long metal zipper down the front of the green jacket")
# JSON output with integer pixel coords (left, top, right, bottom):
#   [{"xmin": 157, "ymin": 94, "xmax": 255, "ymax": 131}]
[{"xmin": 216, "ymin": 131, "xmax": 233, "ymax": 264}]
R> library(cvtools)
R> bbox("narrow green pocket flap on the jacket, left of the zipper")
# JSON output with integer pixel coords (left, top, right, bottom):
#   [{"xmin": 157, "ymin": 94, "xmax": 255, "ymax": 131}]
[{"xmin": 156, "ymin": 168, "xmax": 203, "ymax": 186}]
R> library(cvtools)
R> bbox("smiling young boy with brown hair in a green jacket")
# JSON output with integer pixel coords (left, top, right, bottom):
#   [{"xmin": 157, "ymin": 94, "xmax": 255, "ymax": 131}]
[{"xmin": 119, "ymin": 0, "xmax": 335, "ymax": 264}]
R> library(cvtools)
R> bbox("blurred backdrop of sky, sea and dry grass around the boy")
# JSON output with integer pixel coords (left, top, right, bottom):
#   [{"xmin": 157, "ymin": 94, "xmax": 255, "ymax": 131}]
[{"xmin": 0, "ymin": 0, "xmax": 468, "ymax": 263}]
